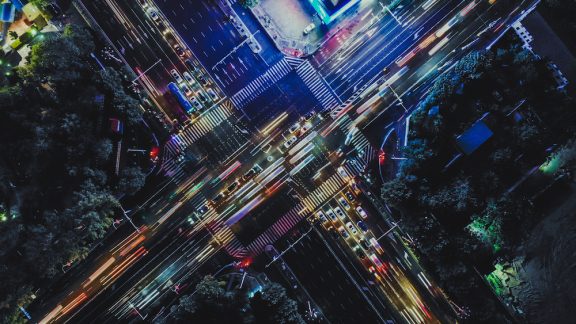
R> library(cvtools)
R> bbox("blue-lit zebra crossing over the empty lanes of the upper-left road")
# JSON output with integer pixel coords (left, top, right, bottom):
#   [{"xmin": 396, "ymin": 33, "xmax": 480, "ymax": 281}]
[{"xmin": 230, "ymin": 59, "xmax": 292, "ymax": 109}]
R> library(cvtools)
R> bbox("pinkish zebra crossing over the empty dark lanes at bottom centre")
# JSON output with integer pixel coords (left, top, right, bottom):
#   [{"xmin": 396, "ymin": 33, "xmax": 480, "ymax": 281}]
[{"xmin": 246, "ymin": 204, "xmax": 307, "ymax": 256}]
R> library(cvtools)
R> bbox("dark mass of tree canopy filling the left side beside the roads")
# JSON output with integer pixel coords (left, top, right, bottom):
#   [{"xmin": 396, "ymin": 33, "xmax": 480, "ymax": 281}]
[{"xmin": 0, "ymin": 25, "xmax": 145, "ymax": 322}]
